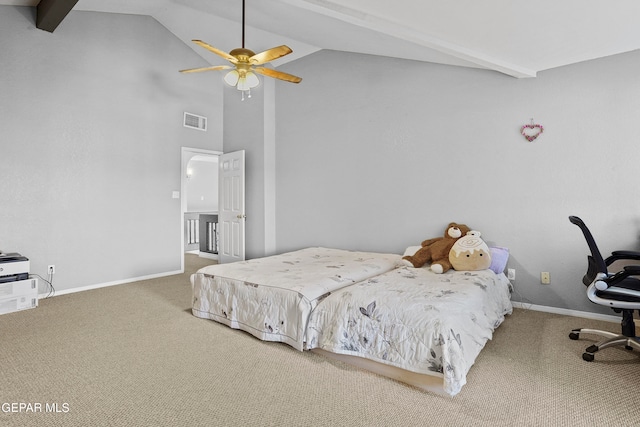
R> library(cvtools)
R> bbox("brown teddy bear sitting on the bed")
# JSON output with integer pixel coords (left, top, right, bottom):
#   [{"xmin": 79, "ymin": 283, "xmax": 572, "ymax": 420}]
[{"xmin": 402, "ymin": 222, "xmax": 471, "ymax": 274}]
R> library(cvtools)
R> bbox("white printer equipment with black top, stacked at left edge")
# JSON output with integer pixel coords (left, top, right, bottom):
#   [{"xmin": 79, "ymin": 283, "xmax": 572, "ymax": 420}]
[{"xmin": 0, "ymin": 253, "xmax": 38, "ymax": 314}]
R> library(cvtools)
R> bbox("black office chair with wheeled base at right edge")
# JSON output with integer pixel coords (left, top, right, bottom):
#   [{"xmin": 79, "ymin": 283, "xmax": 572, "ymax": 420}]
[{"xmin": 569, "ymin": 216, "xmax": 640, "ymax": 362}]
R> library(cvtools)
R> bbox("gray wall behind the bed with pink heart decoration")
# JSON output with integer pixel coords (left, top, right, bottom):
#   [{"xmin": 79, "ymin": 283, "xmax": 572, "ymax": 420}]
[{"xmin": 276, "ymin": 51, "xmax": 640, "ymax": 314}]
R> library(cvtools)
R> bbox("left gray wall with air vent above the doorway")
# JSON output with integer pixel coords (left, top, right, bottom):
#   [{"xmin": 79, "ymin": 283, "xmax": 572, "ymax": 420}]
[{"xmin": 0, "ymin": 6, "xmax": 223, "ymax": 291}]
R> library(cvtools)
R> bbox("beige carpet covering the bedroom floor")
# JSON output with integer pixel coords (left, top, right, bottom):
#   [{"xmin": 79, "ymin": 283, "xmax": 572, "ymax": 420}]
[{"xmin": 0, "ymin": 256, "xmax": 640, "ymax": 426}]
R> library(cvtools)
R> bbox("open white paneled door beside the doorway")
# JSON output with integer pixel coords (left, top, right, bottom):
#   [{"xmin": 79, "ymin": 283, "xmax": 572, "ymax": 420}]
[{"xmin": 218, "ymin": 150, "xmax": 246, "ymax": 264}]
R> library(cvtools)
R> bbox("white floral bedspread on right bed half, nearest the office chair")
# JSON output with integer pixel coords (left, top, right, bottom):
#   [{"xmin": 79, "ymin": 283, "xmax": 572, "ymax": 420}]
[{"xmin": 305, "ymin": 267, "xmax": 512, "ymax": 395}]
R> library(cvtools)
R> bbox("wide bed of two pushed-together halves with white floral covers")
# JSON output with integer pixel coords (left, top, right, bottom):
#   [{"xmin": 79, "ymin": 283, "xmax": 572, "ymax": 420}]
[{"xmin": 191, "ymin": 248, "xmax": 512, "ymax": 396}]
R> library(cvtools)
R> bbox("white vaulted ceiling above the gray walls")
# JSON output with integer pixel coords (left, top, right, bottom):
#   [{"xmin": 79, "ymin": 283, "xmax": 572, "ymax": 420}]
[{"xmin": 5, "ymin": 0, "xmax": 640, "ymax": 78}]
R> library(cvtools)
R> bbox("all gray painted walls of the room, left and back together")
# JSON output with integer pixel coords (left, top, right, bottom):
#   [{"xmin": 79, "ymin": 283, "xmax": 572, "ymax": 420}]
[{"xmin": 0, "ymin": 2, "xmax": 640, "ymax": 314}]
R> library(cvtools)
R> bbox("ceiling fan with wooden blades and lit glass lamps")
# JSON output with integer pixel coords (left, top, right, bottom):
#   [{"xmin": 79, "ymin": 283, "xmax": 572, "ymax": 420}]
[{"xmin": 180, "ymin": 0, "xmax": 302, "ymax": 99}]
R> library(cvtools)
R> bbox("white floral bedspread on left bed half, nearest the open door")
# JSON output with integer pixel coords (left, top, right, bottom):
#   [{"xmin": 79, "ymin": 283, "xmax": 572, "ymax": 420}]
[{"xmin": 191, "ymin": 247, "xmax": 401, "ymax": 351}]
